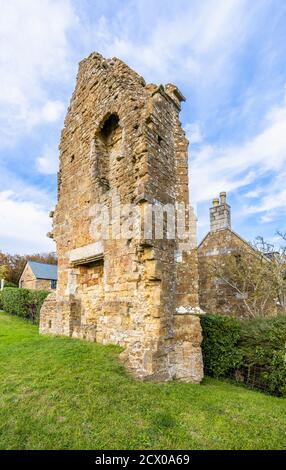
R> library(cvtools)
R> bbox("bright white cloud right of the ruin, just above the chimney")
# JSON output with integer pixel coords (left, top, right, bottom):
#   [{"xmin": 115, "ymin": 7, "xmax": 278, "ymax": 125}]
[{"xmin": 190, "ymin": 93, "xmax": 286, "ymax": 210}]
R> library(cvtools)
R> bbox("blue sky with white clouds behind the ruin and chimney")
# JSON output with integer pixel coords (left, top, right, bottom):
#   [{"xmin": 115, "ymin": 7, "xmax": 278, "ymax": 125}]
[{"xmin": 0, "ymin": 0, "xmax": 286, "ymax": 253}]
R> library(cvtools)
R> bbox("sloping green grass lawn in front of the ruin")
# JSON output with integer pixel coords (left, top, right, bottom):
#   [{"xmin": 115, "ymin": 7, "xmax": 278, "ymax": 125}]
[{"xmin": 0, "ymin": 313, "xmax": 286, "ymax": 449}]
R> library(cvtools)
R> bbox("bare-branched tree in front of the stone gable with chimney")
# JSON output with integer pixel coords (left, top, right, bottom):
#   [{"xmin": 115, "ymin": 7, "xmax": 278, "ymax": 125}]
[{"xmin": 211, "ymin": 234, "xmax": 286, "ymax": 318}]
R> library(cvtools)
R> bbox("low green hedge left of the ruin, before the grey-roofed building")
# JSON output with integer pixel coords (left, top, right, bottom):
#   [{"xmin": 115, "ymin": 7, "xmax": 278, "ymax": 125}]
[{"xmin": 0, "ymin": 287, "xmax": 49, "ymax": 323}]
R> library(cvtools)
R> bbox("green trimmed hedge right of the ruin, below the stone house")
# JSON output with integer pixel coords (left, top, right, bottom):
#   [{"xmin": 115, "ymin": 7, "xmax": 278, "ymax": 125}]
[{"xmin": 202, "ymin": 315, "xmax": 286, "ymax": 395}]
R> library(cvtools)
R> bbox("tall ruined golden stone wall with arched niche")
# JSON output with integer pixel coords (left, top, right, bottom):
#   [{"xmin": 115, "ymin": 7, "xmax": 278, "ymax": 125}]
[{"xmin": 40, "ymin": 53, "xmax": 203, "ymax": 382}]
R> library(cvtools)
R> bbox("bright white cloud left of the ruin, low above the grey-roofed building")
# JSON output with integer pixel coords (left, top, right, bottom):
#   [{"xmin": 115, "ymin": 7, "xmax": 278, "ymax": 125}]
[{"xmin": 0, "ymin": 191, "xmax": 55, "ymax": 253}]
